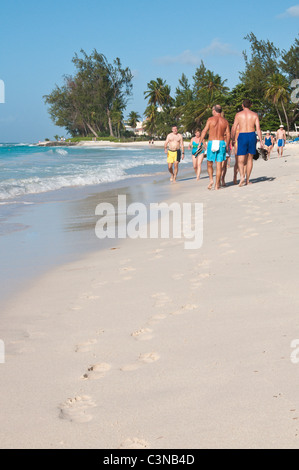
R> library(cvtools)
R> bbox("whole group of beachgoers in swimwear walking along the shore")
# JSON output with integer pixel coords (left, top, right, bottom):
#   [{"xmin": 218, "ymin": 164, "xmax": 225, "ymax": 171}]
[{"xmin": 164, "ymin": 99, "xmax": 286, "ymax": 190}]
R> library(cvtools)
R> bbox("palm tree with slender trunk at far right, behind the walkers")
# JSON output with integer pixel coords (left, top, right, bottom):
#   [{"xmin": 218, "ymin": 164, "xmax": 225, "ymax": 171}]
[{"xmin": 265, "ymin": 73, "xmax": 290, "ymax": 134}]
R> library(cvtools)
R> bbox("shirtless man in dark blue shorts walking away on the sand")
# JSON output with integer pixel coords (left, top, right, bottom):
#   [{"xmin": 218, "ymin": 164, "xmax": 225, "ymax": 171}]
[{"xmin": 232, "ymin": 100, "xmax": 264, "ymax": 186}]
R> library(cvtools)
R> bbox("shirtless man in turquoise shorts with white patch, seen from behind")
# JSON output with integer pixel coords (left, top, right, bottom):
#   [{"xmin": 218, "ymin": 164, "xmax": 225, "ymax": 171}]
[{"xmin": 199, "ymin": 104, "xmax": 230, "ymax": 190}]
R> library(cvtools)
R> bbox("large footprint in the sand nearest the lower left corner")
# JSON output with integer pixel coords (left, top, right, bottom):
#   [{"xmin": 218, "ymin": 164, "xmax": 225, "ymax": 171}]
[{"xmin": 59, "ymin": 395, "xmax": 96, "ymax": 423}]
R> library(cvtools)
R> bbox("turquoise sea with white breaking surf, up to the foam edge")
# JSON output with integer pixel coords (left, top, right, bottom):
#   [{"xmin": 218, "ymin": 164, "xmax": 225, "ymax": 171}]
[{"xmin": 0, "ymin": 143, "xmax": 191, "ymax": 204}]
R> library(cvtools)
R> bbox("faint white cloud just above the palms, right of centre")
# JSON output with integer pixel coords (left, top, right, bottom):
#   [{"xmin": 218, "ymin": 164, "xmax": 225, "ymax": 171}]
[{"xmin": 155, "ymin": 38, "xmax": 240, "ymax": 65}]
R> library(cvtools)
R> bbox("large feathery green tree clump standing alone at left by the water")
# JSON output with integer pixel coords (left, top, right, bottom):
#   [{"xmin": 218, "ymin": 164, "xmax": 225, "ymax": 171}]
[{"xmin": 44, "ymin": 50, "xmax": 133, "ymax": 137}]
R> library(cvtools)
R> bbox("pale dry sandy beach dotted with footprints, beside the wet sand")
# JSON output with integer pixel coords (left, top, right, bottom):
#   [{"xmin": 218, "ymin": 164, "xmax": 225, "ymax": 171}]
[{"xmin": 0, "ymin": 142, "xmax": 299, "ymax": 449}]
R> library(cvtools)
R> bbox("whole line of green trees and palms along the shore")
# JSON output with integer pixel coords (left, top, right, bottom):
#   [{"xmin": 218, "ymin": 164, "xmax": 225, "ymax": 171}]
[{"xmin": 44, "ymin": 33, "xmax": 299, "ymax": 139}]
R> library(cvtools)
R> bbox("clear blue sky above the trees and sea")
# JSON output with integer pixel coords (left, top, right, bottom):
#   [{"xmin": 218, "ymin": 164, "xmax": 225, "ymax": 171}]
[{"xmin": 0, "ymin": 0, "xmax": 299, "ymax": 142}]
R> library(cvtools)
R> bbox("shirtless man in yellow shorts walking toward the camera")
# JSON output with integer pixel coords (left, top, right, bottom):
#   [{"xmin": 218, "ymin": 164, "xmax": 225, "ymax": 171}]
[{"xmin": 164, "ymin": 126, "xmax": 185, "ymax": 183}]
